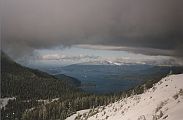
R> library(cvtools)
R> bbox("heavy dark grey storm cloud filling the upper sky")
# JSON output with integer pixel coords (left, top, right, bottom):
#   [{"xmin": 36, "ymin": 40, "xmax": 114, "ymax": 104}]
[{"xmin": 1, "ymin": 0, "xmax": 183, "ymax": 57}]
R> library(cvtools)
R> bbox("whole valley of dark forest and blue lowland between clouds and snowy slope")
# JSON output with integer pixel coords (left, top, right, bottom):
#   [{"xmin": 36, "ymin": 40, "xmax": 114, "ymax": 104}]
[{"xmin": 0, "ymin": 52, "xmax": 183, "ymax": 120}]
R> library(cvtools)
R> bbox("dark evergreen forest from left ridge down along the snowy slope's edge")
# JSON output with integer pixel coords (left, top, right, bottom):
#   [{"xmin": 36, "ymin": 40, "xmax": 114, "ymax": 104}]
[{"xmin": 1, "ymin": 52, "xmax": 182, "ymax": 120}]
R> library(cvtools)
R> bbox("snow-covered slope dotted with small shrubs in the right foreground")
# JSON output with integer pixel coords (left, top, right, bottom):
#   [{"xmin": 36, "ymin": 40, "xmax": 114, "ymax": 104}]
[{"xmin": 67, "ymin": 74, "xmax": 183, "ymax": 120}]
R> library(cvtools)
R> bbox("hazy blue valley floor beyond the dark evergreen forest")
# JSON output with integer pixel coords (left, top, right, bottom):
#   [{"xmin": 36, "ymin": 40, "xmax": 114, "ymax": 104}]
[{"xmin": 47, "ymin": 63, "xmax": 183, "ymax": 94}]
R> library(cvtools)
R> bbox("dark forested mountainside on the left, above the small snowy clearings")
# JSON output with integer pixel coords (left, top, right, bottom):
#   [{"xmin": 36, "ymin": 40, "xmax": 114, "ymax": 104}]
[{"xmin": 1, "ymin": 52, "xmax": 81, "ymax": 99}]
